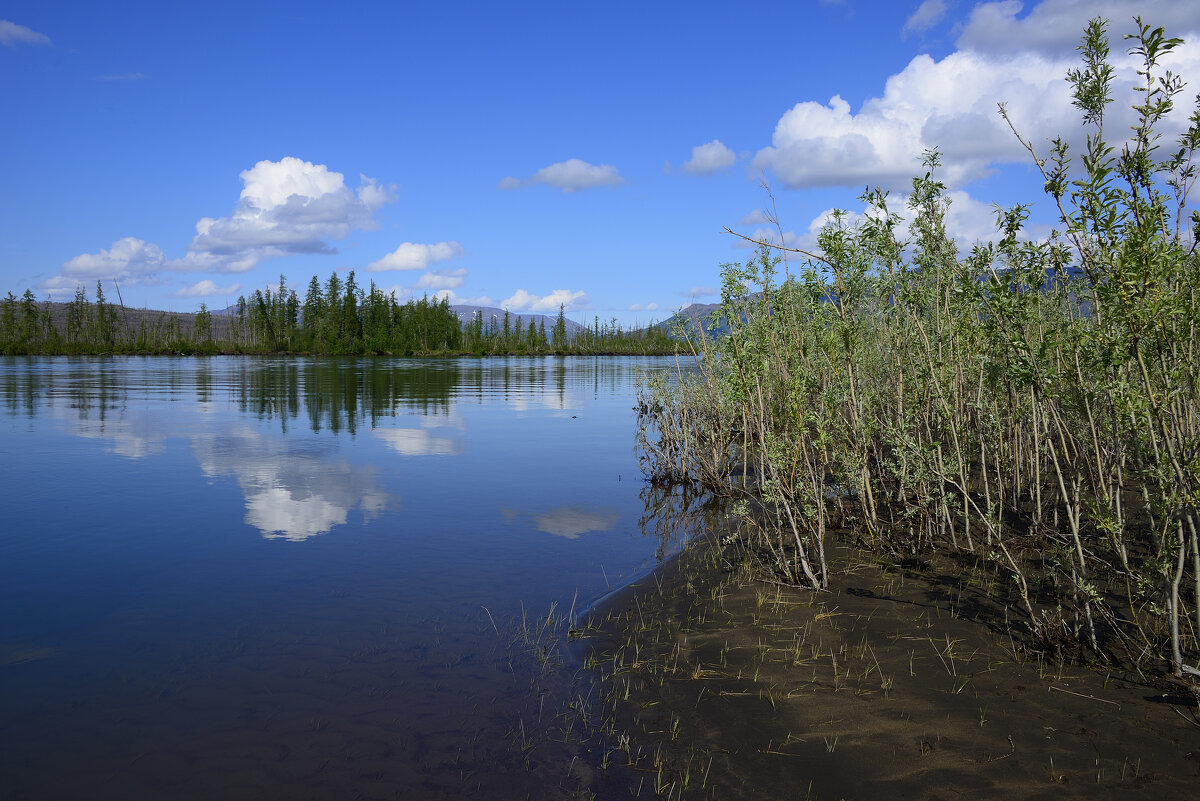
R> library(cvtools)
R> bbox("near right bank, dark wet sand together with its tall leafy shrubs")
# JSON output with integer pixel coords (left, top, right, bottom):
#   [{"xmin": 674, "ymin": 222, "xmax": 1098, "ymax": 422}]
[{"xmin": 547, "ymin": 18, "xmax": 1200, "ymax": 799}]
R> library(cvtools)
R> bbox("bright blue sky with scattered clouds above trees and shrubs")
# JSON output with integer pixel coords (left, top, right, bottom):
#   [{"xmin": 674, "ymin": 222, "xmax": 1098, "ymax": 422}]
[{"xmin": 0, "ymin": 0, "xmax": 1200, "ymax": 324}]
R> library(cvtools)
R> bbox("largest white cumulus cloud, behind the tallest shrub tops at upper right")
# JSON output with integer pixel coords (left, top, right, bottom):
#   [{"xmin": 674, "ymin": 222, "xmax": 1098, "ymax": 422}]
[{"xmin": 754, "ymin": 0, "xmax": 1200, "ymax": 191}]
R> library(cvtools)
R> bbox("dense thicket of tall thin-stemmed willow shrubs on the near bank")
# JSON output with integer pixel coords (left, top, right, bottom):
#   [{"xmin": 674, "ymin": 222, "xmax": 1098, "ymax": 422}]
[{"xmin": 641, "ymin": 19, "xmax": 1200, "ymax": 675}]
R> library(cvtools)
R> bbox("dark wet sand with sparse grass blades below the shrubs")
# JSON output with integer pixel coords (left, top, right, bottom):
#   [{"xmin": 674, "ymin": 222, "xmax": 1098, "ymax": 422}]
[{"xmin": 580, "ymin": 546, "xmax": 1200, "ymax": 799}]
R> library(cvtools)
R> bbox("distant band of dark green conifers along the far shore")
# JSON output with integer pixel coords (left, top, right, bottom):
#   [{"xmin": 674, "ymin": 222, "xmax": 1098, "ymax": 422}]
[{"xmin": 0, "ymin": 271, "xmax": 680, "ymax": 356}]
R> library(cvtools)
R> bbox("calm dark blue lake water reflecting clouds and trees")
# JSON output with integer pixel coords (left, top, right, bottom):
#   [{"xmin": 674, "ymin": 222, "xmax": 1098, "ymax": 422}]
[{"xmin": 0, "ymin": 357, "xmax": 686, "ymax": 800}]
